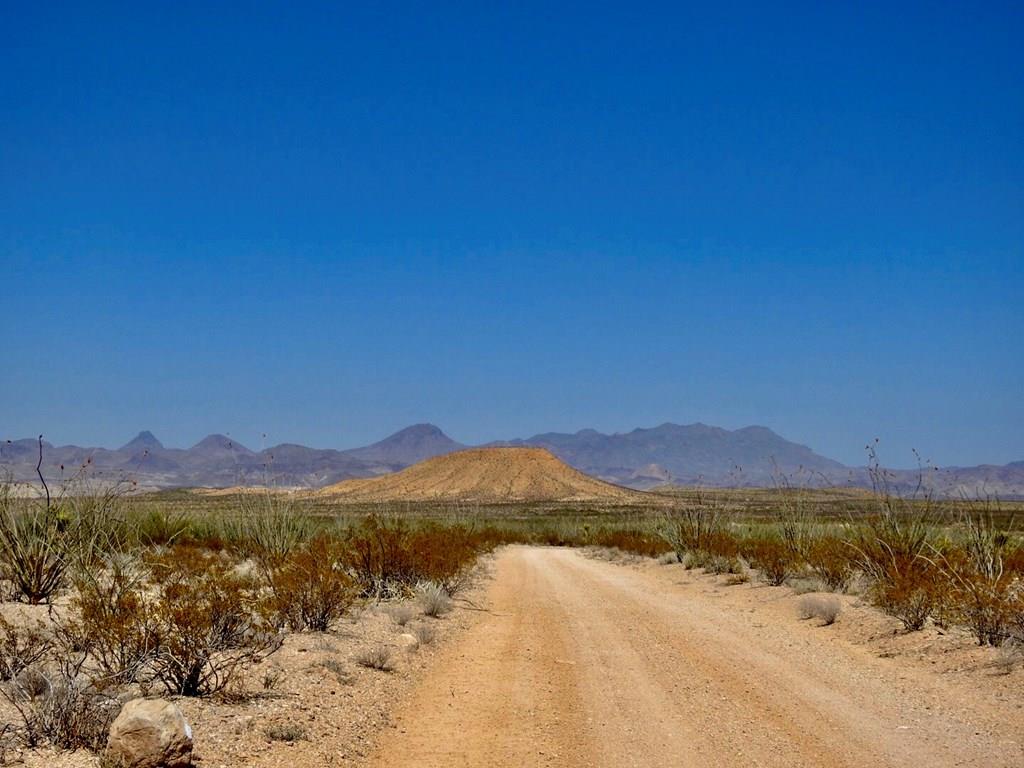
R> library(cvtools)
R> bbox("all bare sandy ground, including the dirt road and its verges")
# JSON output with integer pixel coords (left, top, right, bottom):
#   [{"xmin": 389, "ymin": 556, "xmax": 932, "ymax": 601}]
[{"xmin": 0, "ymin": 547, "xmax": 1024, "ymax": 768}]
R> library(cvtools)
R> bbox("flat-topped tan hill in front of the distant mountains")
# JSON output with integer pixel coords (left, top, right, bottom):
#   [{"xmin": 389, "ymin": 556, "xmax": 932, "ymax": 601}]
[{"xmin": 319, "ymin": 447, "xmax": 646, "ymax": 504}]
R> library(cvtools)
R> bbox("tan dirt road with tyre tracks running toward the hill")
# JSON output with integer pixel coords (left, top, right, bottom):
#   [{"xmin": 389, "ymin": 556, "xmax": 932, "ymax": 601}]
[{"xmin": 371, "ymin": 547, "xmax": 1024, "ymax": 768}]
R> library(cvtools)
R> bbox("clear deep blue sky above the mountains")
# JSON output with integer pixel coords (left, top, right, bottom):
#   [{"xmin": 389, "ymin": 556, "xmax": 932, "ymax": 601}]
[{"xmin": 0, "ymin": 2, "xmax": 1024, "ymax": 466}]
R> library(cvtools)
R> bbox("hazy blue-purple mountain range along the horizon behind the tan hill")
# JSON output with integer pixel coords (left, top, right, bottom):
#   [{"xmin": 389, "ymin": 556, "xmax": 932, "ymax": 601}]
[{"xmin": 0, "ymin": 424, "xmax": 1024, "ymax": 498}]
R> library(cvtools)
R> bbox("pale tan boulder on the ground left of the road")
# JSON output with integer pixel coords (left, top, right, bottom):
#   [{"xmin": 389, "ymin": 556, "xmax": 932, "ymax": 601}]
[{"xmin": 104, "ymin": 698, "xmax": 191, "ymax": 768}]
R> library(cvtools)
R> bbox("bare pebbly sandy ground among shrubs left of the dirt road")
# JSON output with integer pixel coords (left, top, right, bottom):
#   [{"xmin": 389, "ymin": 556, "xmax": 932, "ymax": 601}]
[{"xmin": 0, "ymin": 577, "xmax": 489, "ymax": 768}]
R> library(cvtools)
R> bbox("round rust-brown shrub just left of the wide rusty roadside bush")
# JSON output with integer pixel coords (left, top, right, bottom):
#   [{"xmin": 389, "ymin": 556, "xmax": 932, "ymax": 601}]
[{"xmin": 269, "ymin": 536, "xmax": 357, "ymax": 632}]
